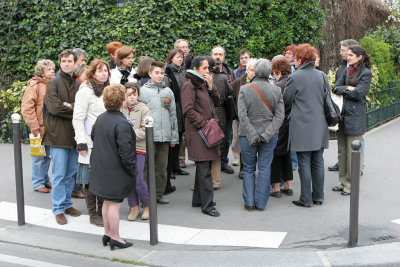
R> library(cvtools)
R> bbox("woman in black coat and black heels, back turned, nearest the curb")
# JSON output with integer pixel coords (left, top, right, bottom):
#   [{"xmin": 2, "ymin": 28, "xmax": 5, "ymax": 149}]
[{"xmin": 90, "ymin": 84, "xmax": 136, "ymax": 250}]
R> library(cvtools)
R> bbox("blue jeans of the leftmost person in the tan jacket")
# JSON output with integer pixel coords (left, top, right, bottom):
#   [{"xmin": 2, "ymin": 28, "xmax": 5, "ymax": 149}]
[{"xmin": 32, "ymin": 146, "xmax": 51, "ymax": 190}]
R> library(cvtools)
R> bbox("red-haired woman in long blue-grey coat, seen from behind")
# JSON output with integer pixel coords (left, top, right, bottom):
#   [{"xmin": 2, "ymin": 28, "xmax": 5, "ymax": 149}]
[{"xmin": 283, "ymin": 44, "xmax": 329, "ymax": 207}]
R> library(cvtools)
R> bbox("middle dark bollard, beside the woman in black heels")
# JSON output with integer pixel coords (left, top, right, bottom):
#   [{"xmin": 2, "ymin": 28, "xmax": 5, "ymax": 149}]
[{"xmin": 144, "ymin": 117, "xmax": 158, "ymax": 245}]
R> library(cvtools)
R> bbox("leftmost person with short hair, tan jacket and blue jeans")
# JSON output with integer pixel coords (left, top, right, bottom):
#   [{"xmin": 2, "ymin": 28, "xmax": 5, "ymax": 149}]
[{"xmin": 21, "ymin": 59, "xmax": 55, "ymax": 193}]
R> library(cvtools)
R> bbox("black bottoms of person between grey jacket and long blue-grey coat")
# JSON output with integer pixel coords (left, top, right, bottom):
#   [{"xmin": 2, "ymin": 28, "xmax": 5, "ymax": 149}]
[{"xmin": 271, "ymin": 152, "xmax": 293, "ymax": 184}]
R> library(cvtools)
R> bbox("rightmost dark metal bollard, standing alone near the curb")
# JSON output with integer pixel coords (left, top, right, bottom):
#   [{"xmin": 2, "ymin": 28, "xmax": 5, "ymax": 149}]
[{"xmin": 349, "ymin": 140, "xmax": 361, "ymax": 246}]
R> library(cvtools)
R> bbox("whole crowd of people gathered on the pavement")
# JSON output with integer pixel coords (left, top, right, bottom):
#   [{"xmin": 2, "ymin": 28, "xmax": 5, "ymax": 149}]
[{"xmin": 21, "ymin": 39, "xmax": 372, "ymax": 249}]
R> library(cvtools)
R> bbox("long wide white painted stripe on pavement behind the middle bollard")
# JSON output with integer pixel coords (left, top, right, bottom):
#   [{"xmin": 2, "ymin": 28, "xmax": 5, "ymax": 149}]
[{"xmin": 0, "ymin": 201, "xmax": 286, "ymax": 248}]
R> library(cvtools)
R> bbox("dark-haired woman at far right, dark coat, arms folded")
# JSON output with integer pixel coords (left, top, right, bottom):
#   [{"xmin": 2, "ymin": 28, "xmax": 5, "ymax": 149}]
[{"xmin": 332, "ymin": 45, "xmax": 372, "ymax": 196}]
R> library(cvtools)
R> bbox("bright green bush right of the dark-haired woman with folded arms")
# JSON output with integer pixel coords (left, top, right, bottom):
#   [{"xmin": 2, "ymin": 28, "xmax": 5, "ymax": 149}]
[{"xmin": 359, "ymin": 35, "xmax": 396, "ymax": 88}]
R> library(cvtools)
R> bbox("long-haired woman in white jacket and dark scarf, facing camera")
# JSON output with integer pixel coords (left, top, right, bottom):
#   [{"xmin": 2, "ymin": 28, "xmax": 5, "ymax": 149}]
[{"xmin": 72, "ymin": 59, "xmax": 110, "ymax": 226}]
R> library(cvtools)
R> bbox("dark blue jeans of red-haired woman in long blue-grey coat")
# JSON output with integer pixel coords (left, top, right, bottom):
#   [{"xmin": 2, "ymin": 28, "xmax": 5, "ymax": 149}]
[{"xmin": 297, "ymin": 148, "xmax": 325, "ymax": 205}]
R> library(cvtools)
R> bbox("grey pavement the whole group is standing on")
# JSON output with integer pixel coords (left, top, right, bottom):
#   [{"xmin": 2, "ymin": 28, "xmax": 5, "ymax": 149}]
[{"xmin": 0, "ymin": 119, "xmax": 400, "ymax": 266}]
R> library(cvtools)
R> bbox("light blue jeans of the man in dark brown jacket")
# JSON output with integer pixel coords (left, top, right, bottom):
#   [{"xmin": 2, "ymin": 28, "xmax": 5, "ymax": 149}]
[{"xmin": 50, "ymin": 147, "xmax": 79, "ymax": 215}]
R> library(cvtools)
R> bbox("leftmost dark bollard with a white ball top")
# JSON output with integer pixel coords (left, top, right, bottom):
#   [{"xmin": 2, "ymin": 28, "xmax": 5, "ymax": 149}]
[{"xmin": 11, "ymin": 113, "xmax": 25, "ymax": 226}]
